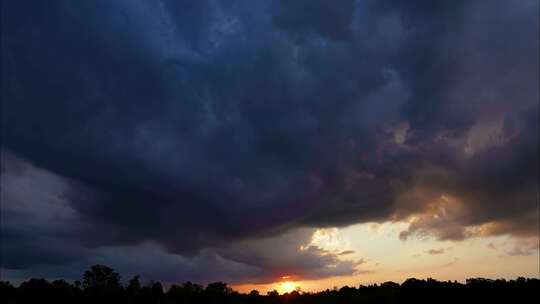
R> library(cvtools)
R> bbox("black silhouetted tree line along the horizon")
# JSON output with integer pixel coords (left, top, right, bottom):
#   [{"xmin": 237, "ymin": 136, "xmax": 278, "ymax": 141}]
[{"xmin": 0, "ymin": 265, "xmax": 540, "ymax": 304}]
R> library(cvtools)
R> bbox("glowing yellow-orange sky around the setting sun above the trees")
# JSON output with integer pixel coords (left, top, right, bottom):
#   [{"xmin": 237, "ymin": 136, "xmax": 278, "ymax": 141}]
[{"xmin": 232, "ymin": 222, "xmax": 540, "ymax": 294}]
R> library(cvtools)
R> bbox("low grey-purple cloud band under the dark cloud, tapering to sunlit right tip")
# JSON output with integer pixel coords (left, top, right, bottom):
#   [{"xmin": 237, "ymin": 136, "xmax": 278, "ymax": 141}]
[{"xmin": 1, "ymin": 151, "xmax": 362, "ymax": 283}]
